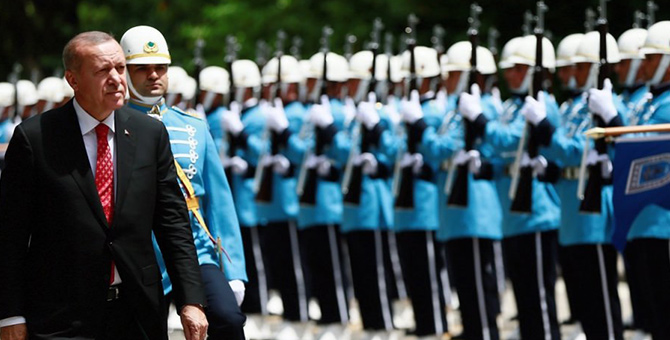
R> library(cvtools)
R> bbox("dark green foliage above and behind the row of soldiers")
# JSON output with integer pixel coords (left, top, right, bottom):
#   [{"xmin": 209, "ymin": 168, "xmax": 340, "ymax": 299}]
[{"xmin": 0, "ymin": 0, "xmax": 670, "ymax": 81}]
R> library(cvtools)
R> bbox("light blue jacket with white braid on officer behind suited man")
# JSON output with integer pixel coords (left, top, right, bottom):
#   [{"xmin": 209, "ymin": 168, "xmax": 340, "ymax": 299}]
[{"xmin": 128, "ymin": 102, "xmax": 247, "ymax": 293}]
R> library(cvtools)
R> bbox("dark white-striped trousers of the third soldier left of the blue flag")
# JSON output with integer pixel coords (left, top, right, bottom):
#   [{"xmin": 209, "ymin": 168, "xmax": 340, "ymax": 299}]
[{"xmin": 445, "ymin": 238, "xmax": 500, "ymax": 340}]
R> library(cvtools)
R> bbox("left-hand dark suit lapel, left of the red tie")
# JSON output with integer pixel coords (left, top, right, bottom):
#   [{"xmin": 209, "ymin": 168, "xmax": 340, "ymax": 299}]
[{"xmin": 61, "ymin": 101, "xmax": 108, "ymax": 231}]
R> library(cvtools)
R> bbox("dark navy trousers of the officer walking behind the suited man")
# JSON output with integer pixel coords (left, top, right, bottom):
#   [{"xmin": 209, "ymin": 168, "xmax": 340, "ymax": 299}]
[{"xmin": 200, "ymin": 264, "xmax": 252, "ymax": 340}]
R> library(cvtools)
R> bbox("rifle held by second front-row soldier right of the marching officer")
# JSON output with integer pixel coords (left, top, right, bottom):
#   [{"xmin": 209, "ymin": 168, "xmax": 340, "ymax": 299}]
[{"xmin": 254, "ymin": 30, "xmax": 286, "ymax": 203}]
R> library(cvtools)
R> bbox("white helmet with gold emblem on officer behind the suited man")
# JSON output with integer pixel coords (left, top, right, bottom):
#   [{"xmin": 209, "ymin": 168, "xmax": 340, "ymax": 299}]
[{"xmin": 121, "ymin": 26, "xmax": 171, "ymax": 65}]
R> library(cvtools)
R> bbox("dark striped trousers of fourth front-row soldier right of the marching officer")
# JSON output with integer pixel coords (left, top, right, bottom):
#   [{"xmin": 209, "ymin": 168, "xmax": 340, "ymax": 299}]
[{"xmin": 344, "ymin": 230, "xmax": 393, "ymax": 330}]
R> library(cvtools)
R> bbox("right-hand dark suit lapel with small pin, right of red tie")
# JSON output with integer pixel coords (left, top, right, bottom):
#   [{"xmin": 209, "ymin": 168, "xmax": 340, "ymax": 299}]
[{"xmin": 114, "ymin": 107, "xmax": 138, "ymax": 224}]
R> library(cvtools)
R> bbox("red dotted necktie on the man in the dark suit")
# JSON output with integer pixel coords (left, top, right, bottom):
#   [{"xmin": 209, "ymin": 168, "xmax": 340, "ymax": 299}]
[{"xmin": 95, "ymin": 124, "xmax": 114, "ymax": 283}]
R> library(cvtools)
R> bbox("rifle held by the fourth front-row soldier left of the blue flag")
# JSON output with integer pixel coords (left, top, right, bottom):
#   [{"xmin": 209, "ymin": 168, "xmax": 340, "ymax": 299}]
[{"xmin": 393, "ymin": 14, "xmax": 419, "ymax": 209}]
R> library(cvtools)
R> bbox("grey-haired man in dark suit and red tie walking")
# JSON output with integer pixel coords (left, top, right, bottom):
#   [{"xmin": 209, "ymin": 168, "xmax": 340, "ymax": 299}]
[{"xmin": 0, "ymin": 32, "xmax": 207, "ymax": 340}]
